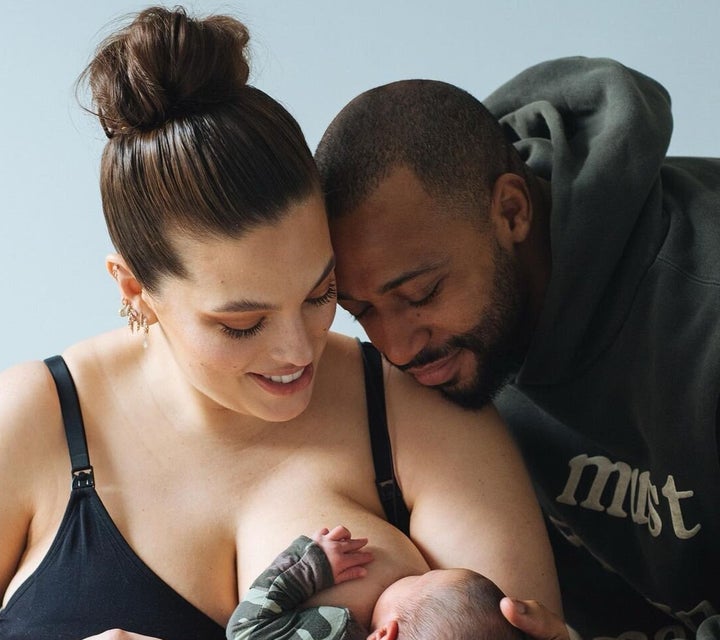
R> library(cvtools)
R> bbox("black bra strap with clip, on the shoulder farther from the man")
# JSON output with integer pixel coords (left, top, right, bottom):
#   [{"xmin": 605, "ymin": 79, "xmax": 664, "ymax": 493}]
[{"xmin": 45, "ymin": 356, "xmax": 95, "ymax": 489}]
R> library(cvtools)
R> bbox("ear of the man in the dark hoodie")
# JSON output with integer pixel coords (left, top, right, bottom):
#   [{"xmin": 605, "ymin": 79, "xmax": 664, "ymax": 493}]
[{"xmin": 490, "ymin": 173, "xmax": 533, "ymax": 249}]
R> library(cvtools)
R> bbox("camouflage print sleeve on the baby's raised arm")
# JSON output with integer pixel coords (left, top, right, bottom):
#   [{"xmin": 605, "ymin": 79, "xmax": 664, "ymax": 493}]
[{"xmin": 227, "ymin": 536, "xmax": 360, "ymax": 640}]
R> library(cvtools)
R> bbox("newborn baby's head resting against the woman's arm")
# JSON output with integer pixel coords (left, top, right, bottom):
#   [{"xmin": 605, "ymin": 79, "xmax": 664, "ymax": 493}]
[{"xmin": 368, "ymin": 569, "xmax": 526, "ymax": 640}]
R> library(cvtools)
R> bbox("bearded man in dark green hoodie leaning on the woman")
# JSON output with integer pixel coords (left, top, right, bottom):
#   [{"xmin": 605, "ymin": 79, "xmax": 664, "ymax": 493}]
[{"xmin": 316, "ymin": 58, "xmax": 720, "ymax": 638}]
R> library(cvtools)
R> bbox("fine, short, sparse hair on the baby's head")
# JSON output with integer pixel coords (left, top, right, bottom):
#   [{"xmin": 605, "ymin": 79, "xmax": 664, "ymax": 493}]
[{"xmin": 398, "ymin": 570, "xmax": 527, "ymax": 640}]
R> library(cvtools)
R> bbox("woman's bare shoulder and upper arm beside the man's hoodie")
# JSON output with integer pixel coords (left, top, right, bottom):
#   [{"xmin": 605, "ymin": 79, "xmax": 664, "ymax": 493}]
[{"xmin": 386, "ymin": 369, "xmax": 562, "ymax": 615}]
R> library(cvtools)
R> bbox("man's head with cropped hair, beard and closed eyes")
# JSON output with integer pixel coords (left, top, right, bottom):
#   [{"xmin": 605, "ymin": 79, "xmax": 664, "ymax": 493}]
[{"xmin": 315, "ymin": 80, "xmax": 544, "ymax": 406}]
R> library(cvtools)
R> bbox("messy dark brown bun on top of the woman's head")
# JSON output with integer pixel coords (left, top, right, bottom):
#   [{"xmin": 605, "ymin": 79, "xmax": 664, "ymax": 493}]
[{"xmin": 81, "ymin": 7, "xmax": 249, "ymax": 137}]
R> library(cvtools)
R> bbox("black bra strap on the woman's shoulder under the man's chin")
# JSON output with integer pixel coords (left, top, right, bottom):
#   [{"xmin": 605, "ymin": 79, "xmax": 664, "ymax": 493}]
[{"xmin": 360, "ymin": 342, "xmax": 410, "ymax": 535}]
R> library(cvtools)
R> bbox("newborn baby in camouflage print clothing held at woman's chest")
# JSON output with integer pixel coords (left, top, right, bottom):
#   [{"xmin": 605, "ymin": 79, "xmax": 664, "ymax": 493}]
[{"xmin": 227, "ymin": 525, "xmax": 526, "ymax": 640}]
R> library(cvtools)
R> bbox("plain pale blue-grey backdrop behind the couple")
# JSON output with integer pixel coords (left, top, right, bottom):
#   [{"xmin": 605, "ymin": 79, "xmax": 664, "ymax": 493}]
[{"xmin": 0, "ymin": 0, "xmax": 720, "ymax": 368}]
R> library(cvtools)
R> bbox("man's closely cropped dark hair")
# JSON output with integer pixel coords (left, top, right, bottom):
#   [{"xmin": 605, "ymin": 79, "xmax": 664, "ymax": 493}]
[{"xmin": 315, "ymin": 80, "xmax": 527, "ymax": 224}]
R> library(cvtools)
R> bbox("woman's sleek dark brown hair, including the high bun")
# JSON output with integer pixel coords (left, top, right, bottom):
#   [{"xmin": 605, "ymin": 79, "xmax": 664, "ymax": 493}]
[{"xmin": 79, "ymin": 7, "xmax": 319, "ymax": 291}]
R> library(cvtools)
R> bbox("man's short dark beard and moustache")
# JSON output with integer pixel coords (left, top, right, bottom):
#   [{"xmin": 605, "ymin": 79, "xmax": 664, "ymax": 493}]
[{"xmin": 401, "ymin": 242, "xmax": 527, "ymax": 409}]
